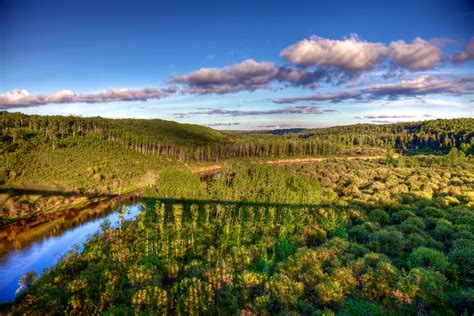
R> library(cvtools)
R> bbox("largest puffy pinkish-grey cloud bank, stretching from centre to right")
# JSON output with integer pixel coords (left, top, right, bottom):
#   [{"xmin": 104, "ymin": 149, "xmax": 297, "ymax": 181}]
[{"xmin": 170, "ymin": 34, "xmax": 465, "ymax": 95}]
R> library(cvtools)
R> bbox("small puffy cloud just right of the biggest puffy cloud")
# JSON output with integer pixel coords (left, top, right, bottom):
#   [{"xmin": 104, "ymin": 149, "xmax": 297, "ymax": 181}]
[{"xmin": 389, "ymin": 37, "xmax": 445, "ymax": 71}]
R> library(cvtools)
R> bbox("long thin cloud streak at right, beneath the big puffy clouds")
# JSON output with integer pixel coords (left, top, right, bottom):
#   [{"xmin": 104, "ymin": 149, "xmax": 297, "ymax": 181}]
[{"xmin": 273, "ymin": 75, "xmax": 474, "ymax": 104}]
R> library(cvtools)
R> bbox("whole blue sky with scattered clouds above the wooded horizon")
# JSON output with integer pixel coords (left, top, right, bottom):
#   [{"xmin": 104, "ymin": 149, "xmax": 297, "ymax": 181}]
[{"xmin": 0, "ymin": 0, "xmax": 474, "ymax": 130}]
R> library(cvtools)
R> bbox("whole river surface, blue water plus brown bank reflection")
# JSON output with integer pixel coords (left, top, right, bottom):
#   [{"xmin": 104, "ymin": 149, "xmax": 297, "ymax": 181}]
[{"xmin": 0, "ymin": 202, "xmax": 142, "ymax": 302}]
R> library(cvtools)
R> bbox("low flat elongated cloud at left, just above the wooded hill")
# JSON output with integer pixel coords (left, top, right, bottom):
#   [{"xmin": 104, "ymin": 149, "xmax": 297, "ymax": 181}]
[{"xmin": 0, "ymin": 88, "xmax": 171, "ymax": 109}]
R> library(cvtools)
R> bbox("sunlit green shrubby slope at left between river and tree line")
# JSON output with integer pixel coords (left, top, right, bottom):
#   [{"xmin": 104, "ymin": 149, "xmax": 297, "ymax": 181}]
[{"xmin": 0, "ymin": 135, "xmax": 170, "ymax": 218}]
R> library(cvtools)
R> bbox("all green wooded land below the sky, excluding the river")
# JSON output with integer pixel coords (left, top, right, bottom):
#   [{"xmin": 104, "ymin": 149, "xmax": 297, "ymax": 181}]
[{"xmin": 0, "ymin": 112, "xmax": 474, "ymax": 315}]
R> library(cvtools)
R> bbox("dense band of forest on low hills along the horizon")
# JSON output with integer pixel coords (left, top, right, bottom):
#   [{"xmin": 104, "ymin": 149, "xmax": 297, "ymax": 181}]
[{"xmin": 0, "ymin": 112, "xmax": 474, "ymax": 161}]
